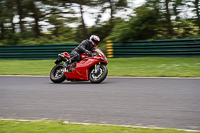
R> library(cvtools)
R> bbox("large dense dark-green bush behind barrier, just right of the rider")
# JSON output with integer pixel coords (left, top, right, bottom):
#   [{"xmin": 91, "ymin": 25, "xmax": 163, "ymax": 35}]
[{"xmin": 107, "ymin": 4, "xmax": 160, "ymax": 42}]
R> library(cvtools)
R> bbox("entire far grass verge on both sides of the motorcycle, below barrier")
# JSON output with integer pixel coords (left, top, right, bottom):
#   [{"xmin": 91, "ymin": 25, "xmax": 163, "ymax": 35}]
[{"xmin": 0, "ymin": 57, "xmax": 200, "ymax": 77}]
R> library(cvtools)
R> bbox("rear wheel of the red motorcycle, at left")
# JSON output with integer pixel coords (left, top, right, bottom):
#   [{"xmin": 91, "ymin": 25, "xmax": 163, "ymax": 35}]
[{"xmin": 50, "ymin": 64, "xmax": 66, "ymax": 83}]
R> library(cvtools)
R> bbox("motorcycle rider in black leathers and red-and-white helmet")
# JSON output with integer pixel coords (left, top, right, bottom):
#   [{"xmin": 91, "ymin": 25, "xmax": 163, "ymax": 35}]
[{"xmin": 64, "ymin": 35, "xmax": 100, "ymax": 68}]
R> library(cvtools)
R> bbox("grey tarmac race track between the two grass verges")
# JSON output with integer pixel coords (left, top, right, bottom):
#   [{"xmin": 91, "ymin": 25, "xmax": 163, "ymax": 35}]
[{"xmin": 0, "ymin": 76, "xmax": 200, "ymax": 130}]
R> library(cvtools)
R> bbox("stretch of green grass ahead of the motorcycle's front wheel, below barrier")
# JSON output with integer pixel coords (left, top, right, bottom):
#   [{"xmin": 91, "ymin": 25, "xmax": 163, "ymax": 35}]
[{"xmin": 109, "ymin": 57, "xmax": 200, "ymax": 77}]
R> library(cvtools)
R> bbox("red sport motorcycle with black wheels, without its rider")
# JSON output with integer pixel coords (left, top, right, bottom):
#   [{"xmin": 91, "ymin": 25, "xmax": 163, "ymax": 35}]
[{"xmin": 50, "ymin": 49, "xmax": 108, "ymax": 83}]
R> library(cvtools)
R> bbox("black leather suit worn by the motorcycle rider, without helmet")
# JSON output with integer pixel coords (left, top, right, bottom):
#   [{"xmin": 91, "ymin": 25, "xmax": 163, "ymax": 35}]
[{"xmin": 70, "ymin": 39, "xmax": 95, "ymax": 62}]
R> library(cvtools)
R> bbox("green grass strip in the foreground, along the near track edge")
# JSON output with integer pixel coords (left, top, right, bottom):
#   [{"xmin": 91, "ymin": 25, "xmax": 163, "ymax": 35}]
[{"xmin": 0, "ymin": 120, "xmax": 200, "ymax": 133}]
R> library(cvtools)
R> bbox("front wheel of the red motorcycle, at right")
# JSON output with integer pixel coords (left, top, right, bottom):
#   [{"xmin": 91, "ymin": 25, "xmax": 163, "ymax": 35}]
[{"xmin": 89, "ymin": 65, "xmax": 108, "ymax": 83}]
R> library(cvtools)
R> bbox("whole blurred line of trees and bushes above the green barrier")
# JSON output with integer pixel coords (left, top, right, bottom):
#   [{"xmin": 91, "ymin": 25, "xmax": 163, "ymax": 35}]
[{"xmin": 0, "ymin": 0, "xmax": 200, "ymax": 45}]
